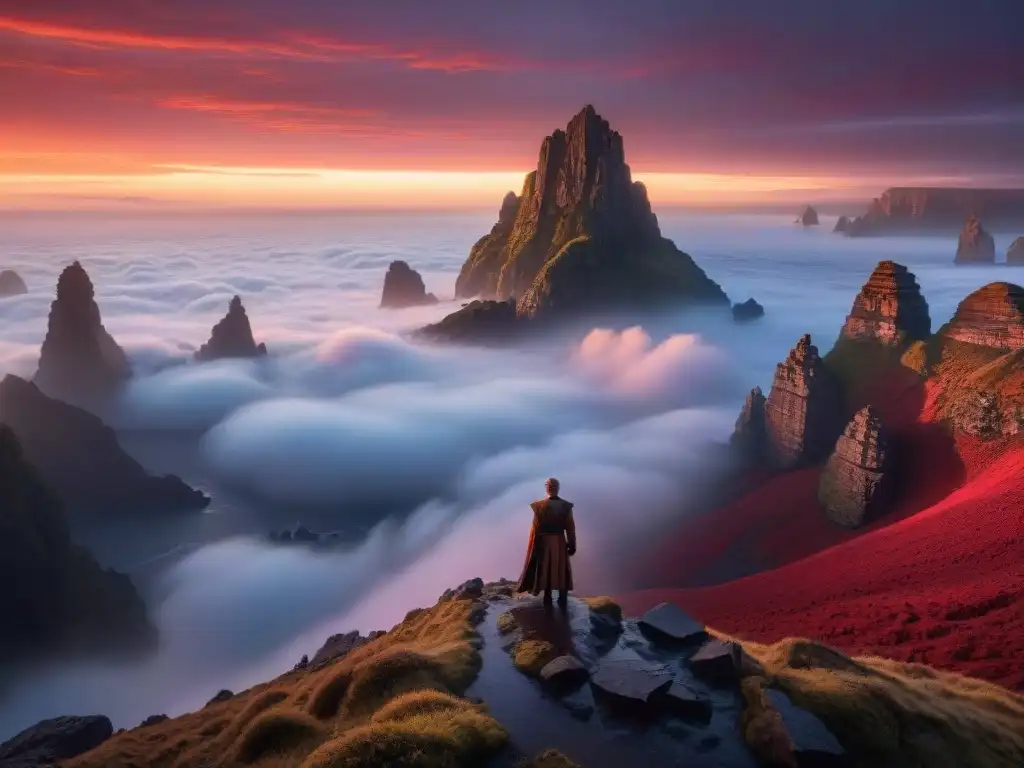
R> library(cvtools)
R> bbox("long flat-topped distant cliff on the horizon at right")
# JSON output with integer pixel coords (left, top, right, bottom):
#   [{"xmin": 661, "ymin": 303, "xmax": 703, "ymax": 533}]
[{"xmin": 846, "ymin": 187, "xmax": 1024, "ymax": 237}]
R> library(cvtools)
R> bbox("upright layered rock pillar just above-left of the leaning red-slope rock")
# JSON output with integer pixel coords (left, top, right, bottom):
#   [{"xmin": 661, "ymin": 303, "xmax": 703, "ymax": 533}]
[{"xmin": 765, "ymin": 335, "xmax": 843, "ymax": 469}]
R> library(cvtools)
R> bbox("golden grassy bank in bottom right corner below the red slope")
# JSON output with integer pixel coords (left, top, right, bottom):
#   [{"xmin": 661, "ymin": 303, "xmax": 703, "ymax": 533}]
[{"xmin": 743, "ymin": 639, "xmax": 1024, "ymax": 768}]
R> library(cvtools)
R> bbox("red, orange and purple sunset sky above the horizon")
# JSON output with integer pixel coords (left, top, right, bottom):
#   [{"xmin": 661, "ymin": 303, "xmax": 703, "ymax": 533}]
[{"xmin": 0, "ymin": 0, "xmax": 1024, "ymax": 208}]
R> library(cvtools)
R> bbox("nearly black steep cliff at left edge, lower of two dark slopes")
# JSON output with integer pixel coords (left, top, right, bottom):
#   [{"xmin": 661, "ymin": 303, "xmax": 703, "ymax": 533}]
[{"xmin": 0, "ymin": 423, "xmax": 156, "ymax": 663}]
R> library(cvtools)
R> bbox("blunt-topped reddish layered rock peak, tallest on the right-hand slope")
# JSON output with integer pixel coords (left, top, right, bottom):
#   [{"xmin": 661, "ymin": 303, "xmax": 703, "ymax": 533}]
[{"xmin": 840, "ymin": 261, "xmax": 932, "ymax": 346}]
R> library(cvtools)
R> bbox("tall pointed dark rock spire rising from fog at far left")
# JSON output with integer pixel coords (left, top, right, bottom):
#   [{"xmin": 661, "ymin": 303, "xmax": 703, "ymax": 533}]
[{"xmin": 34, "ymin": 261, "xmax": 131, "ymax": 403}]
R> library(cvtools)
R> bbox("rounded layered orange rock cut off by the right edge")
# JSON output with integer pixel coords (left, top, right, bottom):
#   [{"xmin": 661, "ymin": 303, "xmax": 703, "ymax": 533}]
[{"xmin": 939, "ymin": 283, "xmax": 1024, "ymax": 351}]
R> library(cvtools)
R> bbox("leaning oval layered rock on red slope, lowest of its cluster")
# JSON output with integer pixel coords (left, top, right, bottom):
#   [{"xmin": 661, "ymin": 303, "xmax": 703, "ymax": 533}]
[{"xmin": 818, "ymin": 406, "xmax": 894, "ymax": 528}]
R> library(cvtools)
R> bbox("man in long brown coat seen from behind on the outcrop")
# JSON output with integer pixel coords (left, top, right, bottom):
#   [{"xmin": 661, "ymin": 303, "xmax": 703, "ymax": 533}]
[{"xmin": 518, "ymin": 477, "xmax": 575, "ymax": 608}]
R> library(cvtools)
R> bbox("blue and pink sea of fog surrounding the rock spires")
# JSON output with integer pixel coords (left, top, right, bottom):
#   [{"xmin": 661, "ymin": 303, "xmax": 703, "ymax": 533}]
[{"xmin": 0, "ymin": 211, "xmax": 1012, "ymax": 740}]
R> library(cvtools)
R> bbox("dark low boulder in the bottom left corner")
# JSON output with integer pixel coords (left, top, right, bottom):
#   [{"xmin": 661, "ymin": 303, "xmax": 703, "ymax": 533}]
[{"xmin": 0, "ymin": 715, "xmax": 114, "ymax": 768}]
